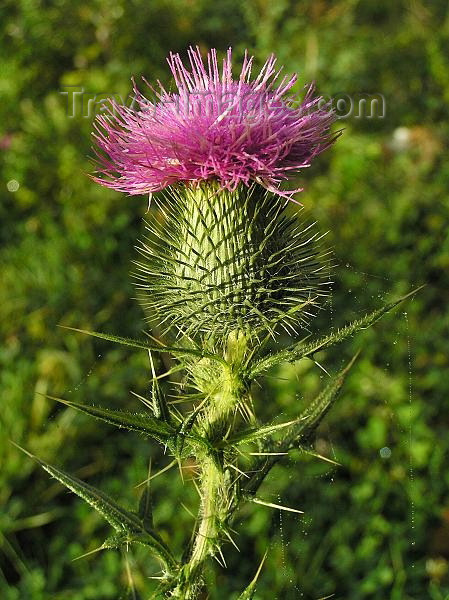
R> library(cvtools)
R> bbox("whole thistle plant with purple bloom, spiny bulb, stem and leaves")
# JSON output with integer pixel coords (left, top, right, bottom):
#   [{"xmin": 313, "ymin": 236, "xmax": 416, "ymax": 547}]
[{"xmin": 15, "ymin": 48, "xmax": 418, "ymax": 600}]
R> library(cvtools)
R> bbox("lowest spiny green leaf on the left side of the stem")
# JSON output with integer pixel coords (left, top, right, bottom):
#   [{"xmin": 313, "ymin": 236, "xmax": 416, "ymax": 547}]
[{"xmin": 12, "ymin": 442, "xmax": 176, "ymax": 569}]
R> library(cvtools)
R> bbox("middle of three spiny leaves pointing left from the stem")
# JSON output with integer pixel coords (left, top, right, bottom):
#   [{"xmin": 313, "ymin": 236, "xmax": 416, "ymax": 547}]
[{"xmin": 47, "ymin": 396, "xmax": 176, "ymax": 443}]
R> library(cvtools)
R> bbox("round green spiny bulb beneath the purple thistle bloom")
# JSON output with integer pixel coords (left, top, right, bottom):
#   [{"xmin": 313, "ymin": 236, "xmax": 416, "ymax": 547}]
[{"xmin": 136, "ymin": 183, "xmax": 328, "ymax": 342}]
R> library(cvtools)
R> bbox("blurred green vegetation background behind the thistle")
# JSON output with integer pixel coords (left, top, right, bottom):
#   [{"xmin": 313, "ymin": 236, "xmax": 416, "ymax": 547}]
[{"xmin": 0, "ymin": 0, "xmax": 449, "ymax": 600}]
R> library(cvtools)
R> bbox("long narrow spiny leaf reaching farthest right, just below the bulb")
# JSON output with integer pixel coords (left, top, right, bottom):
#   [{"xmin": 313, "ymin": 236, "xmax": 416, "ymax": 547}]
[{"xmin": 249, "ymin": 286, "xmax": 424, "ymax": 378}]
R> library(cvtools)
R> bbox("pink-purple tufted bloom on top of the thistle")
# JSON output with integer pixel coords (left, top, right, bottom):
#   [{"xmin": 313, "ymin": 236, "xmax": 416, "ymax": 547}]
[{"xmin": 94, "ymin": 48, "xmax": 338, "ymax": 197}]
